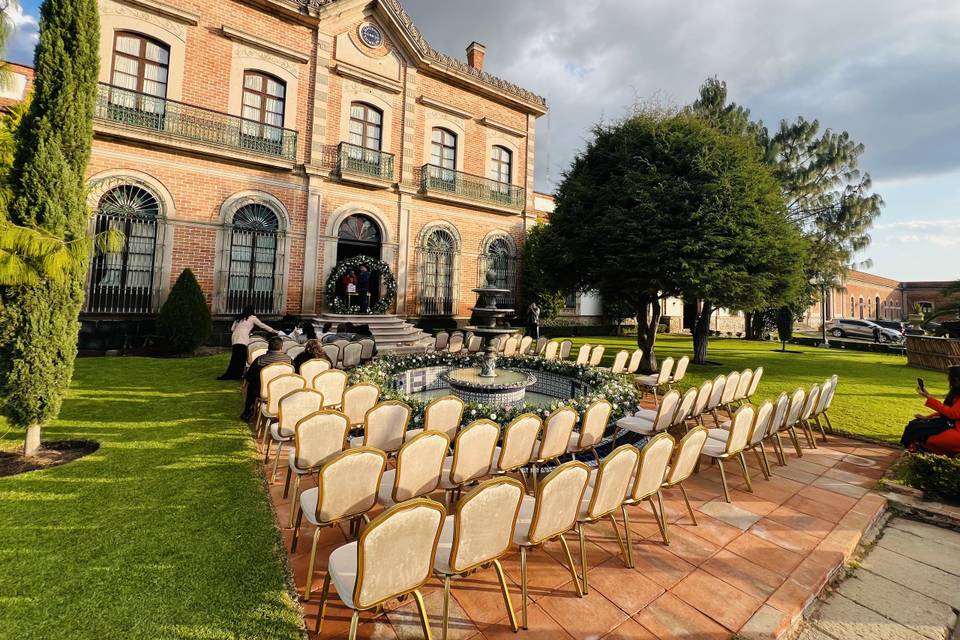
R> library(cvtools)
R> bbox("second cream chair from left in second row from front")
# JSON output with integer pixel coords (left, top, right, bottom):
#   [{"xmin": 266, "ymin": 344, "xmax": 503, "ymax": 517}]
[{"xmin": 377, "ymin": 431, "xmax": 450, "ymax": 507}]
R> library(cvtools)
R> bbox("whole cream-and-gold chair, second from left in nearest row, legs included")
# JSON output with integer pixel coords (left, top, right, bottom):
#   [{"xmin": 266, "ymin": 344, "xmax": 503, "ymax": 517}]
[{"xmin": 433, "ymin": 480, "xmax": 523, "ymax": 640}]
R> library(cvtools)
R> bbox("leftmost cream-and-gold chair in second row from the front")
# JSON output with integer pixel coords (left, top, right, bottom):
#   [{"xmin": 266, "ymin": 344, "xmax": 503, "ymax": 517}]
[{"xmin": 290, "ymin": 449, "xmax": 387, "ymax": 600}]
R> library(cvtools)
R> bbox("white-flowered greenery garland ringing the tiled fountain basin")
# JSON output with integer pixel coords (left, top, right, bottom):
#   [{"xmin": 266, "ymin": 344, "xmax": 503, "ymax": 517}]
[{"xmin": 350, "ymin": 352, "xmax": 640, "ymax": 427}]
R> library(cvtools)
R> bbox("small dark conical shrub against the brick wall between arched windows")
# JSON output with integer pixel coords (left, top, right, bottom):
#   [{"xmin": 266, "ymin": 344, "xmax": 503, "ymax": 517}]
[{"xmin": 157, "ymin": 269, "xmax": 213, "ymax": 353}]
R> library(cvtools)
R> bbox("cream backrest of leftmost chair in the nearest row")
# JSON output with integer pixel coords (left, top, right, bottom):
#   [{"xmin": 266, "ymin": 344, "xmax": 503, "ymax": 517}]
[{"xmin": 353, "ymin": 500, "xmax": 446, "ymax": 609}]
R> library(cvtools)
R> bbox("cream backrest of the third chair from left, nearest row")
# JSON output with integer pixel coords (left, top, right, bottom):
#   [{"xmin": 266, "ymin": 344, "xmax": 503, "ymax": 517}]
[{"xmin": 528, "ymin": 461, "xmax": 590, "ymax": 544}]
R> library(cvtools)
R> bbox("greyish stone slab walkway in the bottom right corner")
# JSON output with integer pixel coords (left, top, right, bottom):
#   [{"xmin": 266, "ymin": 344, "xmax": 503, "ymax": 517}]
[{"xmin": 800, "ymin": 518, "xmax": 960, "ymax": 640}]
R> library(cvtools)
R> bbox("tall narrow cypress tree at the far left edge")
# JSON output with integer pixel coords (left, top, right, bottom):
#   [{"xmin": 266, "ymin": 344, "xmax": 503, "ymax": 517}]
[{"xmin": 0, "ymin": 0, "xmax": 100, "ymax": 455}]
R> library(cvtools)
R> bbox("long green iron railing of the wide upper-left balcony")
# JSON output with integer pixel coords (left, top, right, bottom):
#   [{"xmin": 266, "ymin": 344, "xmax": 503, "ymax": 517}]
[{"xmin": 96, "ymin": 83, "xmax": 297, "ymax": 161}]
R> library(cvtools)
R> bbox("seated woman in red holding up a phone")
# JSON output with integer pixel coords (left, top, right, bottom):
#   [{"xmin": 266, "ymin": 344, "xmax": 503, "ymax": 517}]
[{"xmin": 900, "ymin": 366, "xmax": 960, "ymax": 457}]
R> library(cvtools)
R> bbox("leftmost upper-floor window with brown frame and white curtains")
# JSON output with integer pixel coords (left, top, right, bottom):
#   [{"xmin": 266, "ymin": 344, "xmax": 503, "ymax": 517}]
[{"xmin": 110, "ymin": 31, "xmax": 170, "ymax": 119}]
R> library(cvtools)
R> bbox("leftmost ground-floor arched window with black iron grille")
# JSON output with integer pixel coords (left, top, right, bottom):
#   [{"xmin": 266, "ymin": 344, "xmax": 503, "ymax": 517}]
[{"xmin": 85, "ymin": 179, "xmax": 163, "ymax": 314}]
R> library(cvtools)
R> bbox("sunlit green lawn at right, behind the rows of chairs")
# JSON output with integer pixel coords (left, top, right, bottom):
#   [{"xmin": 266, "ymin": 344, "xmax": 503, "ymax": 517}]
[{"xmin": 574, "ymin": 335, "xmax": 920, "ymax": 443}]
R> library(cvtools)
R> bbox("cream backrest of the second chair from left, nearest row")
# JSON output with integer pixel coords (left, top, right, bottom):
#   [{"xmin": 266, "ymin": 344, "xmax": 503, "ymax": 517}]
[{"xmin": 450, "ymin": 477, "xmax": 523, "ymax": 573}]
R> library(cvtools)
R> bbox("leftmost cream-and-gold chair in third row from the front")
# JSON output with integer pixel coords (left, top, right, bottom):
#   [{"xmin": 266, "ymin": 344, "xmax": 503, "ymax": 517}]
[{"xmin": 283, "ymin": 412, "xmax": 347, "ymax": 527}]
